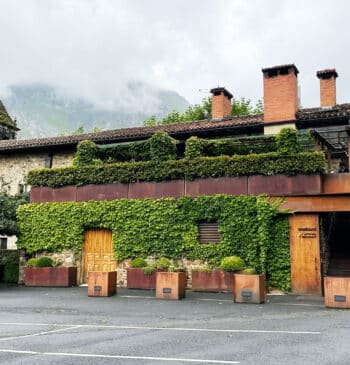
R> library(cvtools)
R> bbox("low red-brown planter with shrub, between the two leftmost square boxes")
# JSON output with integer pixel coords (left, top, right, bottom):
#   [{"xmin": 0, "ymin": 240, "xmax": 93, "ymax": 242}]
[{"xmin": 127, "ymin": 258, "xmax": 156, "ymax": 289}]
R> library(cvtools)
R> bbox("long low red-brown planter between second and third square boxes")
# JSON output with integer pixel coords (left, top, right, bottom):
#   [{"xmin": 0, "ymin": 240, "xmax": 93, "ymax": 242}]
[{"xmin": 192, "ymin": 270, "xmax": 233, "ymax": 292}]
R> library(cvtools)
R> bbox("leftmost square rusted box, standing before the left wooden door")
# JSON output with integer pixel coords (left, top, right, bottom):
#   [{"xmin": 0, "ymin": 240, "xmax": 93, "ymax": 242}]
[{"xmin": 88, "ymin": 271, "xmax": 117, "ymax": 297}]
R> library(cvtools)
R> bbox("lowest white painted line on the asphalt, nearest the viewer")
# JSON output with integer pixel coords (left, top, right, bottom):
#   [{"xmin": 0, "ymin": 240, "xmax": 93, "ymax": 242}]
[{"xmin": 0, "ymin": 349, "xmax": 240, "ymax": 364}]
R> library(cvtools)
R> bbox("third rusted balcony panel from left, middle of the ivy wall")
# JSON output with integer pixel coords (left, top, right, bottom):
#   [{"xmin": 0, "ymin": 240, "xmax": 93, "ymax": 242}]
[{"xmin": 128, "ymin": 180, "xmax": 185, "ymax": 199}]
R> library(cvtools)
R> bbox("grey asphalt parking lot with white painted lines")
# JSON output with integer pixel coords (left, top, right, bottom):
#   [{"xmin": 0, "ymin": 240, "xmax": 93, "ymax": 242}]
[{"xmin": 0, "ymin": 285, "xmax": 350, "ymax": 365}]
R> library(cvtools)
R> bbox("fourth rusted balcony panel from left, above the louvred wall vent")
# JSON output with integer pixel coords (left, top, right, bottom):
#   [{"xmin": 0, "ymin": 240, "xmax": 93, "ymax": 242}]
[{"xmin": 185, "ymin": 176, "xmax": 248, "ymax": 196}]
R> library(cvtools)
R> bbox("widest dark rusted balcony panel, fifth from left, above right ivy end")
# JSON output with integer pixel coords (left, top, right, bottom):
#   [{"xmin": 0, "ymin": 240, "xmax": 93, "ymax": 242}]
[{"xmin": 248, "ymin": 174, "xmax": 322, "ymax": 196}]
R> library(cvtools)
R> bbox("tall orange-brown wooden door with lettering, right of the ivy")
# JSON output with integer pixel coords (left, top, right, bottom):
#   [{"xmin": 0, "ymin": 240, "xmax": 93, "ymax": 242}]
[{"xmin": 289, "ymin": 214, "xmax": 321, "ymax": 294}]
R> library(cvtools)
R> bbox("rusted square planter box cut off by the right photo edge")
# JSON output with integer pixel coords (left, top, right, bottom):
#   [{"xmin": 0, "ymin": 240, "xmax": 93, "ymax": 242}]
[{"xmin": 324, "ymin": 276, "xmax": 350, "ymax": 308}]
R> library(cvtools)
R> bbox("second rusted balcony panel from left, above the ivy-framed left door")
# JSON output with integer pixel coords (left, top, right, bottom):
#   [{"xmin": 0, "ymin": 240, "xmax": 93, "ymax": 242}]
[{"xmin": 77, "ymin": 183, "xmax": 128, "ymax": 201}]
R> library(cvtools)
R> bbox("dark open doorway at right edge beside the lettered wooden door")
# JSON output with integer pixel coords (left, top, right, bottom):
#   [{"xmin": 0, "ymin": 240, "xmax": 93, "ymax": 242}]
[{"xmin": 321, "ymin": 212, "xmax": 350, "ymax": 277}]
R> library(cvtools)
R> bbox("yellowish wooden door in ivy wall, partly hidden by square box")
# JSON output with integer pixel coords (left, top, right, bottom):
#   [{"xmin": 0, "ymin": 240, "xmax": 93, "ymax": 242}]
[{"xmin": 83, "ymin": 229, "xmax": 117, "ymax": 283}]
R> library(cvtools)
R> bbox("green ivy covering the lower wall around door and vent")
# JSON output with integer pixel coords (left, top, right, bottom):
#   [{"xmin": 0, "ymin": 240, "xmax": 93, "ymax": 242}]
[{"xmin": 17, "ymin": 195, "xmax": 290, "ymax": 288}]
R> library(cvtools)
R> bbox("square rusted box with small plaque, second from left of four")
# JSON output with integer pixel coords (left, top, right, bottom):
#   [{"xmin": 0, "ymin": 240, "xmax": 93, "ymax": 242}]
[{"xmin": 156, "ymin": 271, "xmax": 186, "ymax": 300}]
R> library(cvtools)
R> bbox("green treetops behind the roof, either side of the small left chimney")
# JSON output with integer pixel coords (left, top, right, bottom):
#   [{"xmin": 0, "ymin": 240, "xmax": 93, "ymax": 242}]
[{"xmin": 143, "ymin": 96, "xmax": 263, "ymax": 126}]
